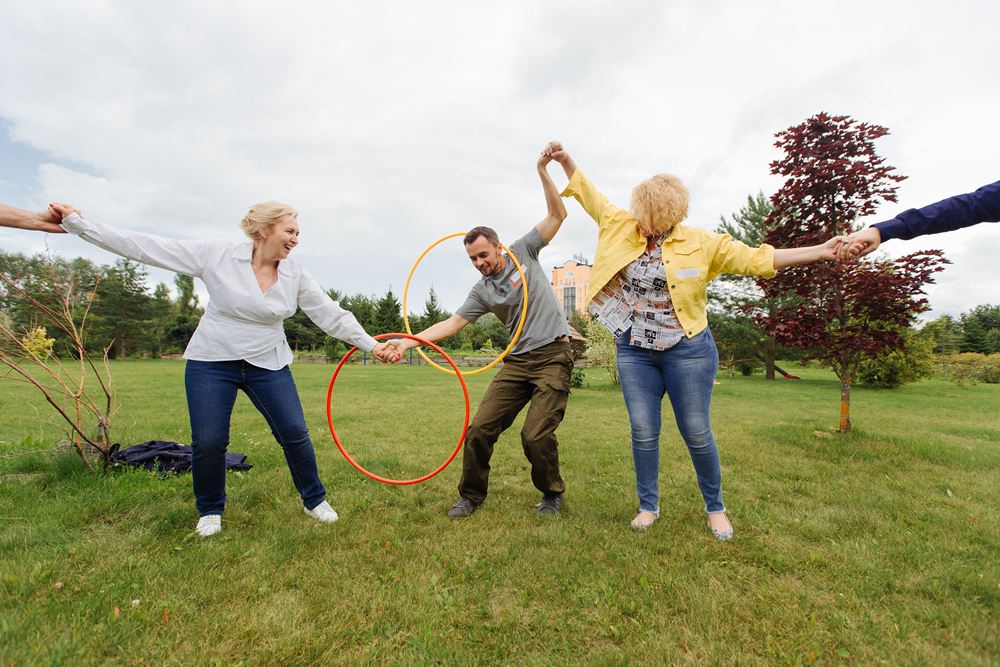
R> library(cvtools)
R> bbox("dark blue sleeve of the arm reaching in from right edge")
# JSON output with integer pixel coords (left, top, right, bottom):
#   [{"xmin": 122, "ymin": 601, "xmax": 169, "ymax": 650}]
[{"xmin": 872, "ymin": 181, "xmax": 1000, "ymax": 242}]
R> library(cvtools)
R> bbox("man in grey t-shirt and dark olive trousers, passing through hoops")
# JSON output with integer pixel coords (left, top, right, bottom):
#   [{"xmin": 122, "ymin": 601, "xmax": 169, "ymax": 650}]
[{"xmin": 393, "ymin": 147, "xmax": 573, "ymax": 519}]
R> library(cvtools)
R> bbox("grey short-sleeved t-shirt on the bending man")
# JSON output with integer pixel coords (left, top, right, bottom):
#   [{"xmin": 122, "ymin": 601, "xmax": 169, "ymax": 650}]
[{"xmin": 456, "ymin": 227, "xmax": 569, "ymax": 354}]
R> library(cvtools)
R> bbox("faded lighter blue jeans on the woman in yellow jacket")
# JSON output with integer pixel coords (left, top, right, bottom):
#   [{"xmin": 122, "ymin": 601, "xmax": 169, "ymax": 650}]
[{"xmin": 616, "ymin": 329, "xmax": 726, "ymax": 512}]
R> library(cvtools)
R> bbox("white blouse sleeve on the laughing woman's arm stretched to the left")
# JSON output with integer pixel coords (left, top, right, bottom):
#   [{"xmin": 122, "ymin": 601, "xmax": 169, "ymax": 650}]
[{"xmin": 62, "ymin": 213, "xmax": 215, "ymax": 278}]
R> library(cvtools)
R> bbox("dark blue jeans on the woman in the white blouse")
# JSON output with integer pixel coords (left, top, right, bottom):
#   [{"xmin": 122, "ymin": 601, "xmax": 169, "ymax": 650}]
[{"xmin": 184, "ymin": 360, "xmax": 326, "ymax": 516}]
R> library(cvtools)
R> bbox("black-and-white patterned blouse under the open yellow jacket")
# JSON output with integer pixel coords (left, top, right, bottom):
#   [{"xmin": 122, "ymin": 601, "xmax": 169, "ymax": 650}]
[{"xmin": 589, "ymin": 238, "xmax": 684, "ymax": 352}]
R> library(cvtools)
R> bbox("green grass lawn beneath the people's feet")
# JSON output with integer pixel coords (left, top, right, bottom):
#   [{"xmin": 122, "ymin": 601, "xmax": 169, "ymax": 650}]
[{"xmin": 0, "ymin": 361, "xmax": 1000, "ymax": 665}]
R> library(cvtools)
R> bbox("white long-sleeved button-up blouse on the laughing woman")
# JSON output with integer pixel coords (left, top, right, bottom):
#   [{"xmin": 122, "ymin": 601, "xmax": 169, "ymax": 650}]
[{"xmin": 62, "ymin": 213, "xmax": 376, "ymax": 370}]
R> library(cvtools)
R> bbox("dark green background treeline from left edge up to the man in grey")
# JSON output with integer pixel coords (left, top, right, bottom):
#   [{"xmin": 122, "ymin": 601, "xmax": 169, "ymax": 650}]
[{"xmin": 0, "ymin": 251, "xmax": 510, "ymax": 359}]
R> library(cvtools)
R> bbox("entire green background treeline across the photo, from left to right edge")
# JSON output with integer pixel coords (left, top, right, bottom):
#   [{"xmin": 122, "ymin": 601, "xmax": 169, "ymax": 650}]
[{"xmin": 0, "ymin": 245, "xmax": 1000, "ymax": 366}]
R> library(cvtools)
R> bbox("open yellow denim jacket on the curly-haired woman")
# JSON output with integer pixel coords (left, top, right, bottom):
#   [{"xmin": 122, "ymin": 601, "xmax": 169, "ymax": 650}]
[{"xmin": 562, "ymin": 169, "xmax": 776, "ymax": 338}]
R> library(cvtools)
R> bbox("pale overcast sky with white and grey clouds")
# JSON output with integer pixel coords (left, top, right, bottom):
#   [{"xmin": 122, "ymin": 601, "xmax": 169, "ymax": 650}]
[{"xmin": 0, "ymin": 0, "xmax": 1000, "ymax": 316}]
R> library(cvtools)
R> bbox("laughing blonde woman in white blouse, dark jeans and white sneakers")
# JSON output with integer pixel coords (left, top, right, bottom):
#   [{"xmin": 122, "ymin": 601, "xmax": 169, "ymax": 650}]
[{"xmin": 49, "ymin": 201, "xmax": 399, "ymax": 537}]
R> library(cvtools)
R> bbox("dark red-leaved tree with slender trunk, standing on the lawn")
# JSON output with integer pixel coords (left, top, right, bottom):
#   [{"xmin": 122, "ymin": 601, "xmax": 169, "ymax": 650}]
[{"xmin": 758, "ymin": 113, "xmax": 948, "ymax": 431}]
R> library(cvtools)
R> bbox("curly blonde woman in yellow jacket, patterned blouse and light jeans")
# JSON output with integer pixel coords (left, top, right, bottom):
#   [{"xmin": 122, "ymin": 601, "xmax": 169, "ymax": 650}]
[{"xmin": 546, "ymin": 142, "xmax": 840, "ymax": 540}]
